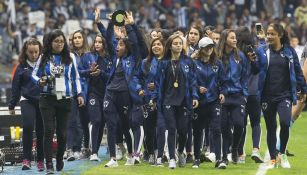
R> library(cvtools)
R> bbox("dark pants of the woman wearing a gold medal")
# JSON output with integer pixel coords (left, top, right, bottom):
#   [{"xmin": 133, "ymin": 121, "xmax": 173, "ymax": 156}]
[{"xmin": 163, "ymin": 105, "xmax": 189, "ymax": 159}]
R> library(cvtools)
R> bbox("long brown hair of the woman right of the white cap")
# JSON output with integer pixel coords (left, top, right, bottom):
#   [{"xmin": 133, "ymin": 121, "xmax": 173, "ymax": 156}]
[{"xmin": 216, "ymin": 29, "xmax": 241, "ymax": 65}]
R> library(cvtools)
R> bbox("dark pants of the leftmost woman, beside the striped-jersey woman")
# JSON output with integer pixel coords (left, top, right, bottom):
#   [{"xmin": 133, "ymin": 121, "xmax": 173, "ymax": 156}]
[{"xmin": 20, "ymin": 100, "xmax": 44, "ymax": 161}]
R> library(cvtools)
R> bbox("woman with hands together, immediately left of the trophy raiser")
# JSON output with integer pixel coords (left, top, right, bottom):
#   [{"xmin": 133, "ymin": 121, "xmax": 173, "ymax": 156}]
[{"xmin": 79, "ymin": 34, "xmax": 112, "ymax": 161}]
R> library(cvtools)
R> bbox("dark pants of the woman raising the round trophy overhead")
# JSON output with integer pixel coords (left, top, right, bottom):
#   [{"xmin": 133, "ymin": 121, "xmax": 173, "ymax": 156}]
[{"xmin": 103, "ymin": 90, "xmax": 132, "ymax": 157}]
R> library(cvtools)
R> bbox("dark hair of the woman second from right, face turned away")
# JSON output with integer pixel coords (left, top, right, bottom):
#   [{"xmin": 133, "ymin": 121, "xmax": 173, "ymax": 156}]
[{"xmin": 236, "ymin": 26, "xmax": 255, "ymax": 55}]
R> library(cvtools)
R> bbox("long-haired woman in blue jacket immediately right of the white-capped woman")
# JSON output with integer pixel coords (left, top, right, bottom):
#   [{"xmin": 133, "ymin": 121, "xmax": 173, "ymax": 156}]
[{"xmin": 217, "ymin": 29, "xmax": 248, "ymax": 164}]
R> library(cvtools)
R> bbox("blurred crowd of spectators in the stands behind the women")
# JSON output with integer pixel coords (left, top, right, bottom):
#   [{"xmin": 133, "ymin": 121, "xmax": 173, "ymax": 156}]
[{"xmin": 0, "ymin": 0, "xmax": 307, "ymax": 64}]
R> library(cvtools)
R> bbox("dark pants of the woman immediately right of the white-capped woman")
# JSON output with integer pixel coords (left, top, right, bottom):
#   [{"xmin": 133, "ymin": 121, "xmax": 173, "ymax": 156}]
[{"xmin": 222, "ymin": 94, "xmax": 246, "ymax": 159}]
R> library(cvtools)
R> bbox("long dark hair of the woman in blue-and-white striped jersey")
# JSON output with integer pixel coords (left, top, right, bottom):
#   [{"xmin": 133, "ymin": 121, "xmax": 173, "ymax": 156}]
[{"xmin": 40, "ymin": 29, "xmax": 72, "ymax": 67}]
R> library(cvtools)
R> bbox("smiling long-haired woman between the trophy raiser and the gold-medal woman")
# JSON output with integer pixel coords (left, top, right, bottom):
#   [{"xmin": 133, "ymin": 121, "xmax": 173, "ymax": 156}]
[{"xmin": 141, "ymin": 37, "xmax": 165, "ymax": 166}]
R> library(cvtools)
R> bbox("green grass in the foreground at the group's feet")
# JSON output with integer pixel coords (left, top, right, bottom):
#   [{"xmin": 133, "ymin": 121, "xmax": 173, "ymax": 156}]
[{"xmin": 83, "ymin": 113, "xmax": 307, "ymax": 175}]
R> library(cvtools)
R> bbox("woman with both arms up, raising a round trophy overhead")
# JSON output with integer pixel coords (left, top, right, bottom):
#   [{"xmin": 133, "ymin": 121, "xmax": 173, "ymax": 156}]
[{"xmin": 103, "ymin": 10, "xmax": 144, "ymax": 167}]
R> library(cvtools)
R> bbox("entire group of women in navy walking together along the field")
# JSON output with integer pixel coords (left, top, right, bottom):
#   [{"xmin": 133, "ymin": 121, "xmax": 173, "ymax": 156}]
[{"xmin": 9, "ymin": 9, "xmax": 307, "ymax": 174}]
